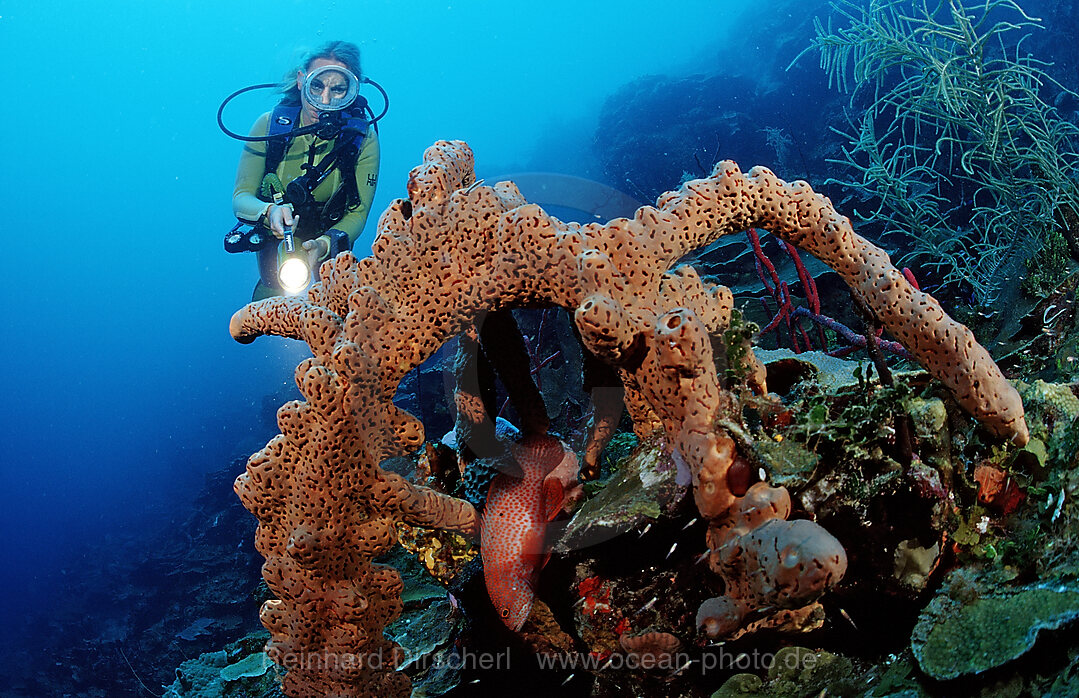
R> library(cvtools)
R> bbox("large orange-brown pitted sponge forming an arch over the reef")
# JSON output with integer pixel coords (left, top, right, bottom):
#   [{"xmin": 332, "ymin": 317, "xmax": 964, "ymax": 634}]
[{"xmin": 230, "ymin": 141, "xmax": 1027, "ymax": 696}]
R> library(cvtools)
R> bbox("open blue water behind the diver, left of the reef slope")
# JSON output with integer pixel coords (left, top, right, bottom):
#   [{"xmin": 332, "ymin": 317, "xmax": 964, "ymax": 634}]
[{"xmin": 0, "ymin": 0, "xmax": 1070, "ymax": 694}]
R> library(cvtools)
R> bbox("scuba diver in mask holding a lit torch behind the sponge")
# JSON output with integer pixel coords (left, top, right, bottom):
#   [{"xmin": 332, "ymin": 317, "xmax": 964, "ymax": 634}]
[{"xmin": 218, "ymin": 41, "xmax": 390, "ymax": 301}]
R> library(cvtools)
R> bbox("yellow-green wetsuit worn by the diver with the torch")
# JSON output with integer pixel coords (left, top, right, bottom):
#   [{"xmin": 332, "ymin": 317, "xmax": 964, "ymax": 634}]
[{"xmin": 232, "ymin": 112, "xmax": 379, "ymax": 300}]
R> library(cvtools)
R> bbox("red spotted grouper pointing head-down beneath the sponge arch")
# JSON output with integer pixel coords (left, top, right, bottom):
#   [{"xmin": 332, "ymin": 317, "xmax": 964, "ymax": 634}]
[{"xmin": 480, "ymin": 435, "xmax": 572, "ymax": 632}]
